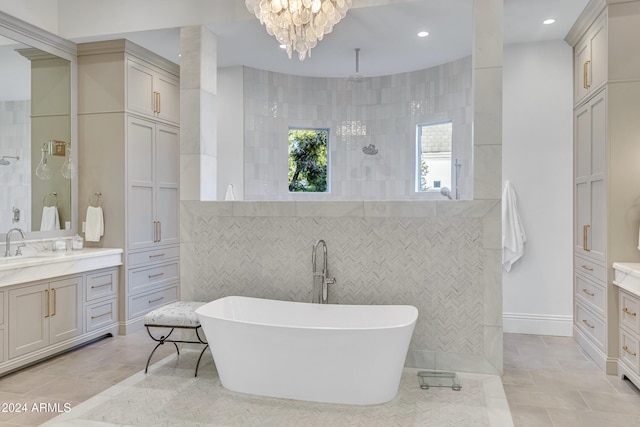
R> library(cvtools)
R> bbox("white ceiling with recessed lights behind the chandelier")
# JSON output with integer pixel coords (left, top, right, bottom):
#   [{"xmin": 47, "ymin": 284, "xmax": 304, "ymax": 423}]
[{"xmin": 81, "ymin": 0, "xmax": 588, "ymax": 77}]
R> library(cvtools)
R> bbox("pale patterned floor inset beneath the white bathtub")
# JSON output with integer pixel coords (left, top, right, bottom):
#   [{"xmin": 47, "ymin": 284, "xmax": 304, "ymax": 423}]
[{"xmin": 44, "ymin": 350, "xmax": 513, "ymax": 427}]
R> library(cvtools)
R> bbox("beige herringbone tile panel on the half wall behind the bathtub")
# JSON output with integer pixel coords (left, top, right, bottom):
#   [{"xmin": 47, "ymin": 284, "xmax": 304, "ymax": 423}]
[{"xmin": 182, "ymin": 202, "xmax": 485, "ymax": 370}]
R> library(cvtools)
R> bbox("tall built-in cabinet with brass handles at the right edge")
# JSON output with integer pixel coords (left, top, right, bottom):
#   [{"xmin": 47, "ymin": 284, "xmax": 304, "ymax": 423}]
[{"xmin": 566, "ymin": 0, "xmax": 640, "ymax": 374}]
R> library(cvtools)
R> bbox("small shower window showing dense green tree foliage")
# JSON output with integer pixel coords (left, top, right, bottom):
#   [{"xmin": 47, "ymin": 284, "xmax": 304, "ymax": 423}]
[{"xmin": 289, "ymin": 128, "xmax": 329, "ymax": 193}]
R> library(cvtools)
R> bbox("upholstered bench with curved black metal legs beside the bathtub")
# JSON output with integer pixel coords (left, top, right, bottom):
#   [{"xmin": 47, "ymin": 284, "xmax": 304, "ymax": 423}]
[{"xmin": 144, "ymin": 301, "xmax": 209, "ymax": 377}]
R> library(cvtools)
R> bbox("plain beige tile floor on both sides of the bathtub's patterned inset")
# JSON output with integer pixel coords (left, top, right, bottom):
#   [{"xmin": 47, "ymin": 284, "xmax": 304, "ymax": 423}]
[{"xmin": 0, "ymin": 331, "xmax": 640, "ymax": 427}]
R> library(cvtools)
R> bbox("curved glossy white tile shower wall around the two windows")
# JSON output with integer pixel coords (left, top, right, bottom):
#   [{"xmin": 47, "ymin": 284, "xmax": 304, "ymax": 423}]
[{"xmin": 244, "ymin": 57, "xmax": 472, "ymax": 200}]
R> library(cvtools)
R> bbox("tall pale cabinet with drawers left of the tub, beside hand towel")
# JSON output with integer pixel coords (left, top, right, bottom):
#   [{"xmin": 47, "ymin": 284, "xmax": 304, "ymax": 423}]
[{"xmin": 78, "ymin": 40, "xmax": 180, "ymax": 333}]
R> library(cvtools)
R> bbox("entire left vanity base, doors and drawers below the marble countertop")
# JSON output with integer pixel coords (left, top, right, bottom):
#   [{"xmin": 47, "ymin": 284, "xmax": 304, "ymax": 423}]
[{"xmin": 0, "ymin": 266, "xmax": 119, "ymax": 374}]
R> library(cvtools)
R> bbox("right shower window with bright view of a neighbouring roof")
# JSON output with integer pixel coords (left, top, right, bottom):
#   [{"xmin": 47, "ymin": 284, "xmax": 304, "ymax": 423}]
[{"xmin": 416, "ymin": 121, "xmax": 453, "ymax": 192}]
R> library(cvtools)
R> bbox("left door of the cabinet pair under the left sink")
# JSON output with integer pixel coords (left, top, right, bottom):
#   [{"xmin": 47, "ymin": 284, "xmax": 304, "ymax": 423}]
[{"xmin": 9, "ymin": 283, "xmax": 51, "ymax": 358}]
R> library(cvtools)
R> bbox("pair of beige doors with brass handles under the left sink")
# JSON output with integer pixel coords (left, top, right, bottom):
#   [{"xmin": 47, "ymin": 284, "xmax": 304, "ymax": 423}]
[{"xmin": 8, "ymin": 276, "xmax": 83, "ymax": 358}]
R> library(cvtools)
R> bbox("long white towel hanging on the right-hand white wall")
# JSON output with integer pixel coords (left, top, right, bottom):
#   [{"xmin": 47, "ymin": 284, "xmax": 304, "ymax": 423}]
[{"xmin": 502, "ymin": 181, "xmax": 527, "ymax": 271}]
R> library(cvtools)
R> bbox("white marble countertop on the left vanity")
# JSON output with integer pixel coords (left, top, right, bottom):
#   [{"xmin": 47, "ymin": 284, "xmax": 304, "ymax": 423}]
[{"xmin": 0, "ymin": 248, "xmax": 123, "ymax": 287}]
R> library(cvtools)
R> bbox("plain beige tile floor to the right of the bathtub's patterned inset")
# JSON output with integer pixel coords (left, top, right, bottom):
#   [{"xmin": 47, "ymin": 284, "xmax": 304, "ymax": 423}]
[{"xmin": 502, "ymin": 334, "xmax": 640, "ymax": 427}]
